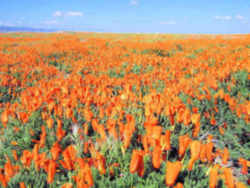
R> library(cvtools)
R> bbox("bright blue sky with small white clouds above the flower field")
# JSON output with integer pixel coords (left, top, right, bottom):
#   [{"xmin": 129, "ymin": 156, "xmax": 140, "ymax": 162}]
[{"xmin": 0, "ymin": 0, "xmax": 250, "ymax": 33}]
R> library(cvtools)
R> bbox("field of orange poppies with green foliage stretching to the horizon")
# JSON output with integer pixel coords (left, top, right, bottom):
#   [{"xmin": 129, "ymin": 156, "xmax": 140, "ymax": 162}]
[{"xmin": 0, "ymin": 32, "xmax": 250, "ymax": 188}]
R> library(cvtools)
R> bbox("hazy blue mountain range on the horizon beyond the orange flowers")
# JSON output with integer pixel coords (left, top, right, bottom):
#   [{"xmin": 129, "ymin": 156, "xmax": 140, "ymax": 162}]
[{"xmin": 0, "ymin": 25, "xmax": 59, "ymax": 33}]
